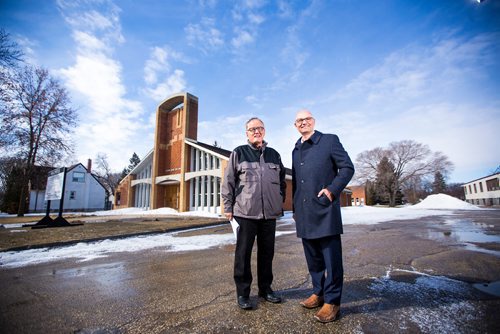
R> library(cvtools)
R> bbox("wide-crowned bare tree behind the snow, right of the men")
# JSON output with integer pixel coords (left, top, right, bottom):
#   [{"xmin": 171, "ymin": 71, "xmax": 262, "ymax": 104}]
[{"xmin": 356, "ymin": 140, "xmax": 453, "ymax": 206}]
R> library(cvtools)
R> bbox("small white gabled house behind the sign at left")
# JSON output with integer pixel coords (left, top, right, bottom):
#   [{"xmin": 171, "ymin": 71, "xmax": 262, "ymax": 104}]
[{"xmin": 29, "ymin": 160, "xmax": 106, "ymax": 212}]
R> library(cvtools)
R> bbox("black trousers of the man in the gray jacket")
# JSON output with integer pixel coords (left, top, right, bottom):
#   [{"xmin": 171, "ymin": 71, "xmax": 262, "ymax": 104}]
[{"xmin": 234, "ymin": 217, "xmax": 276, "ymax": 297}]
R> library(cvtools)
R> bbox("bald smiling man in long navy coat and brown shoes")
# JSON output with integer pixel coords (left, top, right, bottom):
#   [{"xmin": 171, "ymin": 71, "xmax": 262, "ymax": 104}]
[{"xmin": 292, "ymin": 110, "xmax": 354, "ymax": 322}]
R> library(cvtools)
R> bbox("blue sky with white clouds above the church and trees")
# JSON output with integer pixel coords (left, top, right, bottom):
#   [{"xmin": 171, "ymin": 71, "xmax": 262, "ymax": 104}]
[{"xmin": 0, "ymin": 0, "xmax": 500, "ymax": 182}]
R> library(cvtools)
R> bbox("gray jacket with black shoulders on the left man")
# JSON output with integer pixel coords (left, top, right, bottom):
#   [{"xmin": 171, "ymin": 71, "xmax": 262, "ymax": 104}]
[{"xmin": 221, "ymin": 142, "xmax": 286, "ymax": 219}]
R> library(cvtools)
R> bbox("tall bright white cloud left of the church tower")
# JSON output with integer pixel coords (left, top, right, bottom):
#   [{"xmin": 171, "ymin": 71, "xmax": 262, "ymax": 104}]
[{"xmin": 57, "ymin": 1, "xmax": 152, "ymax": 170}]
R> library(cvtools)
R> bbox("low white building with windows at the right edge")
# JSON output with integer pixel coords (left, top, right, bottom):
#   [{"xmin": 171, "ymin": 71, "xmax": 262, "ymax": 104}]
[{"xmin": 462, "ymin": 173, "xmax": 500, "ymax": 206}]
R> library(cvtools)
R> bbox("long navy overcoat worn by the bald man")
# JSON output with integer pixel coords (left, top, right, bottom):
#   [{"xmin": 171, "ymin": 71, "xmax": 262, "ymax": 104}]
[{"xmin": 292, "ymin": 131, "xmax": 354, "ymax": 239}]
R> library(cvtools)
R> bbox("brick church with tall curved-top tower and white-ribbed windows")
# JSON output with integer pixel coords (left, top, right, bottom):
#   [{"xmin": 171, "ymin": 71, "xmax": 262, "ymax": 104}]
[{"xmin": 114, "ymin": 93, "xmax": 351, "ymax": 214}]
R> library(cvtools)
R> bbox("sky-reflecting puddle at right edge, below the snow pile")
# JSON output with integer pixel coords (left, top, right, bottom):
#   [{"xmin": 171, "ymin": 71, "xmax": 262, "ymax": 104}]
[{"xmin": 425, "ymin": 219, "xmax": 500, "ymax": 257}]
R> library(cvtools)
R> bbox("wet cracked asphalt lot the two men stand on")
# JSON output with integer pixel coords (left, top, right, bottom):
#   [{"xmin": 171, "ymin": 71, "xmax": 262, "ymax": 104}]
[{"xmin": 0, "ymin": 210, "xmax": 500, "ymax": 333}]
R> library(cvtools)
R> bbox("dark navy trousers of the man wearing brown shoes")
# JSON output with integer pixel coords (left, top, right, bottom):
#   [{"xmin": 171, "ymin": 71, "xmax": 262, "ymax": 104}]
[{"xmin": 302, "ymin": 234, "xmax": 344, "ymax": 305}]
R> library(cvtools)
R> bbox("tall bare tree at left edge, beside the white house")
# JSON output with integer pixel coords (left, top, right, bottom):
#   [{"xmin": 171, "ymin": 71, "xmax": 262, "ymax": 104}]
[{"xmin": 0, "ymin": 66, "xmax": 77, "ymax": 216}]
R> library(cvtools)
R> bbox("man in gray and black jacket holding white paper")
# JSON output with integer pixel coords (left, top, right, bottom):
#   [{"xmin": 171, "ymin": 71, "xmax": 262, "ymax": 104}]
[{"xmin": 221, "ymin": 117, "xmax": 286, "ymax": 310}]
